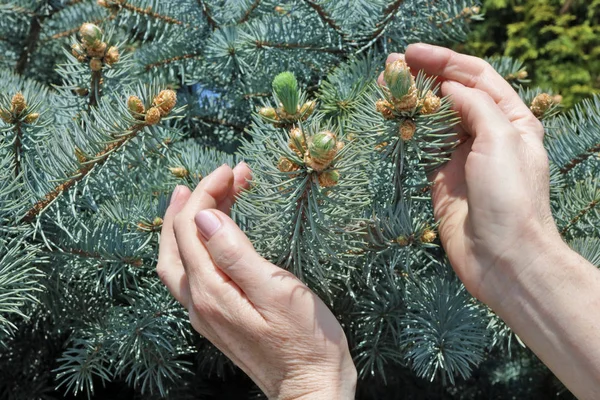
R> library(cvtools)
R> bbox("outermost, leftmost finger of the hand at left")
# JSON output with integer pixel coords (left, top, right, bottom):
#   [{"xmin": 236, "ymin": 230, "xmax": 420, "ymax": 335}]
[{"xmin": 156, "ymin": 185, "xmax": 192, "ymax": 305}]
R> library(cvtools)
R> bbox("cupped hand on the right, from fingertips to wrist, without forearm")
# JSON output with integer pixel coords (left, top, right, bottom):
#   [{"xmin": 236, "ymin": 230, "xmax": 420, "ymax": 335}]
[{"xmin": 379, "ymin": 44, "xmax": 561, "ymax": 308}]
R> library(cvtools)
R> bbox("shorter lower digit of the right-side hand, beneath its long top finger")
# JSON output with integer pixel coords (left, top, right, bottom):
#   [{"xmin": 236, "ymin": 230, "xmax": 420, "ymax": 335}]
[{"xmin": 442, "ymin": 81, "xmax": 519, "ymax": 141}]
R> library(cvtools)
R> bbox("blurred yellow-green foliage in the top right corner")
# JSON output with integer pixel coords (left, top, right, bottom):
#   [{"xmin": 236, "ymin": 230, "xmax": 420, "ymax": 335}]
[{"xmin": 456, "ymin": 0, "xmax": 600, "ymax": 108}]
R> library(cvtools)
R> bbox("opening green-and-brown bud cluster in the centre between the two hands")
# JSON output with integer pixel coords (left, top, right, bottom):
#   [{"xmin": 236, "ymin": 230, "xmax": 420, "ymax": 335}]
[{"xmin": 277, "ymin": 128, "xmax": 344, "ymax": 188}]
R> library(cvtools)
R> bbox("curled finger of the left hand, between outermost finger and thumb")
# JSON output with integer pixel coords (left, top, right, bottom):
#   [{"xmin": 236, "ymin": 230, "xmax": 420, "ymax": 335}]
[{"xmin": 174, "ymin": 165, "xmax": 234, "ymax": 294}]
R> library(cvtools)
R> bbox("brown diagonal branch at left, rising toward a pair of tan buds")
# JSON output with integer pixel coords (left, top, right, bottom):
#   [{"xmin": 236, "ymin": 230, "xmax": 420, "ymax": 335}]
[{"xmin": 23, "ymin": 125, "xmax": 144, "ymax": 221}]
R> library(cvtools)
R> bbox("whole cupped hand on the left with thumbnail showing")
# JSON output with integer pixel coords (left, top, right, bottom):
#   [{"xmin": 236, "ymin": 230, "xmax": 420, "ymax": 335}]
[{"xmin": 157, "ymin": 163, "xmax": 356, "ymax": 399}]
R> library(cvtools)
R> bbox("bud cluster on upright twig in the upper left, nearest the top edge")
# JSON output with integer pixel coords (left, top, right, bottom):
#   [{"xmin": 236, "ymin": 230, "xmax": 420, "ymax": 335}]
[{"xmin": 71, "ymin": 22, "xmax": 119, "ymax": 71}]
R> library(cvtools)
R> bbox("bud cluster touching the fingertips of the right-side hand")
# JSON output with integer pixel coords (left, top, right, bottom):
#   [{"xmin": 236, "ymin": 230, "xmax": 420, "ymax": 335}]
[{"xmin": 375, "ymin": 60, "xmax": 442, "ymax": 120}]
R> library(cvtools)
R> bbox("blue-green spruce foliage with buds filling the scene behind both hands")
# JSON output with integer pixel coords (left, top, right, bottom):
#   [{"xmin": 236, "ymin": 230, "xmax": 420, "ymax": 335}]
[{"xmin": 0, "ymin": 0, "xmax": 600, "ymax": 400}]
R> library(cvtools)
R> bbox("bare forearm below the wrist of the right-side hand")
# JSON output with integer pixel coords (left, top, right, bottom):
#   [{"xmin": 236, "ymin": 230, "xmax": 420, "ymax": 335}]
[{"xmin": 495, "ymin": 242, "xmax": 600, "ymax": 400}]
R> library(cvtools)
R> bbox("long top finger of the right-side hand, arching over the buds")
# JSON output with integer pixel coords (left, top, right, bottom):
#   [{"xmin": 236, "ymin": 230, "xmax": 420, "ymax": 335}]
[{"xmin": 406, "ymin": 43, "xmax": 543, "ymax": 134}]
